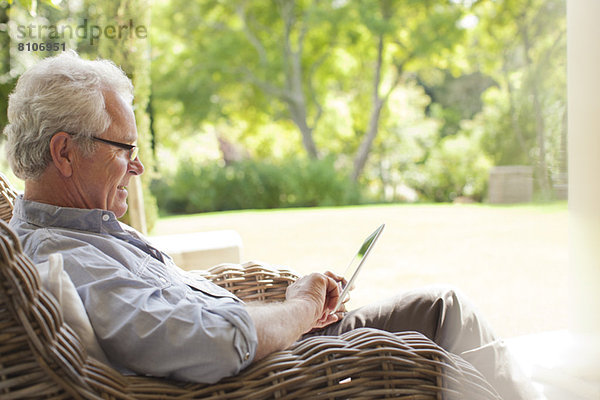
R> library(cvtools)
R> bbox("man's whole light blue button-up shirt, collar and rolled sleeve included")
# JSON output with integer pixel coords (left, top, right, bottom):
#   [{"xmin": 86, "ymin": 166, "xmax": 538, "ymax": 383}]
[{"xmin": 10, "ymin": 197, "xmax": 258, "ymax": 383}]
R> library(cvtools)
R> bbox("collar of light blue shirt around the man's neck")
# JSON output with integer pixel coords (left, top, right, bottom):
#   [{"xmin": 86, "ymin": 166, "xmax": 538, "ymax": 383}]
[{"xmin": 13, "ymin": 195, "xmax": 123, "ymax": 234}]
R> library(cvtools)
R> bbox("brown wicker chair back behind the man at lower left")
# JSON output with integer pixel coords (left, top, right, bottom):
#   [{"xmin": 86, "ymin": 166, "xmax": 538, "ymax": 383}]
[{"xmin": 0, "ymin": 217, "xmax": 127, "ymax": 399}]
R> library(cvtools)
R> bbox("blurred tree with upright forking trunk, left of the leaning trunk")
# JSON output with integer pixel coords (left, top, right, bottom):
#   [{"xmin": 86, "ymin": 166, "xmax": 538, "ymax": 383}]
[{"xmin": 150, "ymin": 0, "xmax": 336, "ymax": 158}]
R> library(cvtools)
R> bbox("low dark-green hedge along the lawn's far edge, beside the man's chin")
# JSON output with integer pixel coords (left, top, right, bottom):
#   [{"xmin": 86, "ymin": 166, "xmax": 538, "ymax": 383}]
[{"xmin": 152, "ymin": 158, "xmax": 362, "ymax": 214}]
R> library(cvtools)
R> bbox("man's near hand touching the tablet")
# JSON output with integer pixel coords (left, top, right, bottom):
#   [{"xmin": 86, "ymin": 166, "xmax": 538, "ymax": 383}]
[{"xmin": 286, "ymin": 273, "xmax": 340, "ymax": 332}]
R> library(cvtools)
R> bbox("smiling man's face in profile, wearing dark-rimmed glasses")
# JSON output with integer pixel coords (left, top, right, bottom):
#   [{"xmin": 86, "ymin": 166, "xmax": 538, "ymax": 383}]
[{"xmin": 74, "ymin": 92, "xmax": 144, "ymax": 218}]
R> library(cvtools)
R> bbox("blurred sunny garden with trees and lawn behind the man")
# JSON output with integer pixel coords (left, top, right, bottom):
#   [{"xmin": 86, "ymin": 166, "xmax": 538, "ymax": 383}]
[{"xmin": 0, "ymin": 0, "xmax": 569, "ymax": 337}]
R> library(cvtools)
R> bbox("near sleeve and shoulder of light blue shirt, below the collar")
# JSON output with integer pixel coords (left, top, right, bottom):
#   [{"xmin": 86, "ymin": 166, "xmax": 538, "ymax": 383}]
[{"xmin": 22, "ymin": 230, "xmax": 258, "ymax": 383}]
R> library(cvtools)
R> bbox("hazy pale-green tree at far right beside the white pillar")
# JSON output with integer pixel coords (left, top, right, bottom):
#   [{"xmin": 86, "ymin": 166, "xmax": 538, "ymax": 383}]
[{"xmin": 475, "ymin": 0, "xmax": 566, "ymax": 198}]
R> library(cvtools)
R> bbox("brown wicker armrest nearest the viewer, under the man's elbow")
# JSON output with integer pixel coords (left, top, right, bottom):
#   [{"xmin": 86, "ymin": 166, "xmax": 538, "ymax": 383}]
[{"xmin": 127, "ymin": 328, "xmax": 500, "ymax": 400}]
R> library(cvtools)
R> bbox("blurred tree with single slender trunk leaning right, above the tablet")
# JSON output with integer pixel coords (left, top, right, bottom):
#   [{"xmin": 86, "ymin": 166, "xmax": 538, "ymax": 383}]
[{"xmin": 352, "ymin": 0, "xmax": 463, "ymax": 180}]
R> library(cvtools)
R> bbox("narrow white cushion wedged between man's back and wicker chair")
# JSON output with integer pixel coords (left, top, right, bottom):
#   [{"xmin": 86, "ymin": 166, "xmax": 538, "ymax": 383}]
[{"xmin": 36, "ymin": 253, "xmax": 107, "ymax": 363}]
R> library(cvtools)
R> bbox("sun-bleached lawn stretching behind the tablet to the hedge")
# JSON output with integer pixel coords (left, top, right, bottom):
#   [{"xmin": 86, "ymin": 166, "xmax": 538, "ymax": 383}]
[{"xmin": 153, "ymin": 203, "xmax": 569, "ymax": 337}]
